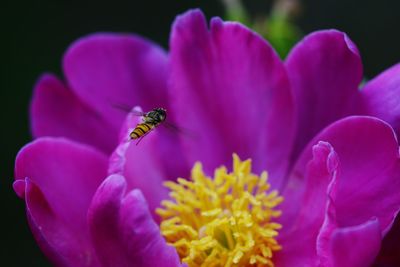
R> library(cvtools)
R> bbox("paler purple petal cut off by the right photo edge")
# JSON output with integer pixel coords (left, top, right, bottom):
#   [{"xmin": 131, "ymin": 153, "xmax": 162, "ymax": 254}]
[{"xmin": 361, "ymin": 64, "xmax": 400, "ymax": 136}]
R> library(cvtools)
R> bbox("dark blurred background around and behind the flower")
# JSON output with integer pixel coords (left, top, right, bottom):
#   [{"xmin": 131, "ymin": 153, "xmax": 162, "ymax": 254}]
[{"xmin": 0, "ymin": 0, "xmax": 400, "ymax": 266}]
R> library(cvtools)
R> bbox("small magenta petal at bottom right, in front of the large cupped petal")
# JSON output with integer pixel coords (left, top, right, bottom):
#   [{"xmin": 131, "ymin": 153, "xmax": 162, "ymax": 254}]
[{"xmin": 322, "ymin": 218, "xmax": 381, "ymax": 267}]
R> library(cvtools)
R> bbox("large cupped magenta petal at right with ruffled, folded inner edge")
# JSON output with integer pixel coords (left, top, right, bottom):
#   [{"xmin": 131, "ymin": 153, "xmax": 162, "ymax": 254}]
[{"xmin": 279, "ymin": 117, "xmax": 400, "ymax": 266}]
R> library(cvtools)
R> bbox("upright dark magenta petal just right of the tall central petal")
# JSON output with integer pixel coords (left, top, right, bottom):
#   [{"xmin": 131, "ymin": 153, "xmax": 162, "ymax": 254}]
[{"xmin": 286, "ymin": 30, "xmax": 362, "ymax": 161}]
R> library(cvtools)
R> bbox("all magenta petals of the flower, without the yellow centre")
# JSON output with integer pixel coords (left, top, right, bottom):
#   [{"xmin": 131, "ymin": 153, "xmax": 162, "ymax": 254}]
[{"xmin": 14, "ymin": 10, "xmax": 400, "ymax": 267}]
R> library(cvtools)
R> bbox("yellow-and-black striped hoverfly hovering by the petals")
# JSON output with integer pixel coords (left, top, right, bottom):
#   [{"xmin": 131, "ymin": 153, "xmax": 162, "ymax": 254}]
[{"xmin": 129, "ymin": 108, "xmax": 167, "ymax": 144}]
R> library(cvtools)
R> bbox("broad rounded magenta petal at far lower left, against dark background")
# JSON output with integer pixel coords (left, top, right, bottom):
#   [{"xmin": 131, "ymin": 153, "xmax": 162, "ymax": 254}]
[{"xmin": 14, "ymin": 138, "xmax": 107, "ymax": 266}]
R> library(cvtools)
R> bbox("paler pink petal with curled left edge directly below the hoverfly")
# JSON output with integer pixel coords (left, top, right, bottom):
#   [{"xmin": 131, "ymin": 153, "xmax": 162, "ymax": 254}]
[{"xmin": 109, "ymin": 111, "xmax": 189, "ymax": 220}]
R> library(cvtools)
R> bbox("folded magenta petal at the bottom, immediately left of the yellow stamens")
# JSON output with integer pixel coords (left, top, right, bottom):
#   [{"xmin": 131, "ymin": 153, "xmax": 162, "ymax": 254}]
[{"xmin": 89, "ymin": 175, "xmax": 179, "ymax": 267}]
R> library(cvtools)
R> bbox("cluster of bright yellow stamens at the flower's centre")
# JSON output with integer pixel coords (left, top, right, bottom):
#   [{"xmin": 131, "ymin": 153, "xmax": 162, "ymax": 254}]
[{"xmin": 156, "ymin": 154, "xmax": 283, "ymax": 267}]
